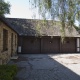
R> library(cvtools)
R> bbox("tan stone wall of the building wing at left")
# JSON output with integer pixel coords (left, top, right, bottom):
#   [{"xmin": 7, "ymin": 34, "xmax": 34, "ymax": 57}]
[{"xmin": 0, "ymin": 22, "xmax": 18, "ymax": 64}]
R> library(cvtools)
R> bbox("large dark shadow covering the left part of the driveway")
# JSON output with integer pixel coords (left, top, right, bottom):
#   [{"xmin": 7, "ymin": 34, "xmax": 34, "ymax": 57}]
[{"xmin": 8, "ymin": 54, "xmax": 80, "ymax": 80}]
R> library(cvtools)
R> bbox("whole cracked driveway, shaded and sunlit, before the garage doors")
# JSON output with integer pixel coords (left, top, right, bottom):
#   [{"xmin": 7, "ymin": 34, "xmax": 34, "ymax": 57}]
[{"xmin": 8, "ymin": 54, "xmax": 80, "ymax": 80}]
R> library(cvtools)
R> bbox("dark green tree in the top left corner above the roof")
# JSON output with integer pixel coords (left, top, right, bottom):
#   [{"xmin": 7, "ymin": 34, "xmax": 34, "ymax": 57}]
[{"xmin": 0, "ymin": 0, "xmax": 10, "ymax": 16}]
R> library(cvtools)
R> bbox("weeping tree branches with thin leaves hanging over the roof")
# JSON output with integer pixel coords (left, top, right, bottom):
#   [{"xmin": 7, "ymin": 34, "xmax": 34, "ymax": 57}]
[{"xmin": 30, "ymin": 0, "xmax": 80, "ymax": 37}]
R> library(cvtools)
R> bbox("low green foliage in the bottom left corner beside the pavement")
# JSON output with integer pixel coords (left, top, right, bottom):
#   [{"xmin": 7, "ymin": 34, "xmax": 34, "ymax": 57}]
[{"xmin": 0, "ymin": 65, "xmax": 18, "ymax": 80}]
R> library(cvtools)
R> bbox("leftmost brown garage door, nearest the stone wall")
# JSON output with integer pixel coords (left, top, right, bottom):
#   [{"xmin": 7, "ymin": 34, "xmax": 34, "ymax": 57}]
[{"xmin": 22, "ymin": 37, "xmax": 40, "ymax": 53}]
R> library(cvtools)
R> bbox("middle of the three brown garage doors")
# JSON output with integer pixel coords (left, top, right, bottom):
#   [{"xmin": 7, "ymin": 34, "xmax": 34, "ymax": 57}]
[{"xmin": 41, "ymin": 37, "xmax": 60, "ymax": 53}]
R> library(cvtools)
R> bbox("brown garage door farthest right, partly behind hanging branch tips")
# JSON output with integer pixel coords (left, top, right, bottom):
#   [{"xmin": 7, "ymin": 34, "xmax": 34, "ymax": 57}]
[{"xmin": 61, "ymin": 38, "xmax": 76, "ymax": 53}]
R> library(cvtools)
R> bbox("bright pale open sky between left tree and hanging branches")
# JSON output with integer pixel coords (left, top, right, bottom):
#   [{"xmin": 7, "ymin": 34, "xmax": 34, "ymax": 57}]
[{"xmin": 5, "ymin": 0, "xmax": 39, "ymax": 19}]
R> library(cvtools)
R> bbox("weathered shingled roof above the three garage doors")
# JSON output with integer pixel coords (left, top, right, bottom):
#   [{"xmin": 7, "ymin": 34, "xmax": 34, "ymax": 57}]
[{"xmin": 1, "ymin": 18, "xmax": 80, "ymax": 37}]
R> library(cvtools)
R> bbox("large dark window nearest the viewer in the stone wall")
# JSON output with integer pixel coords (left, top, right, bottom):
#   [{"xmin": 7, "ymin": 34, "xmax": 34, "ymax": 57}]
[{"xmin": 3, "ymin": 29, "xmax": 8, "ymax": 51}]
